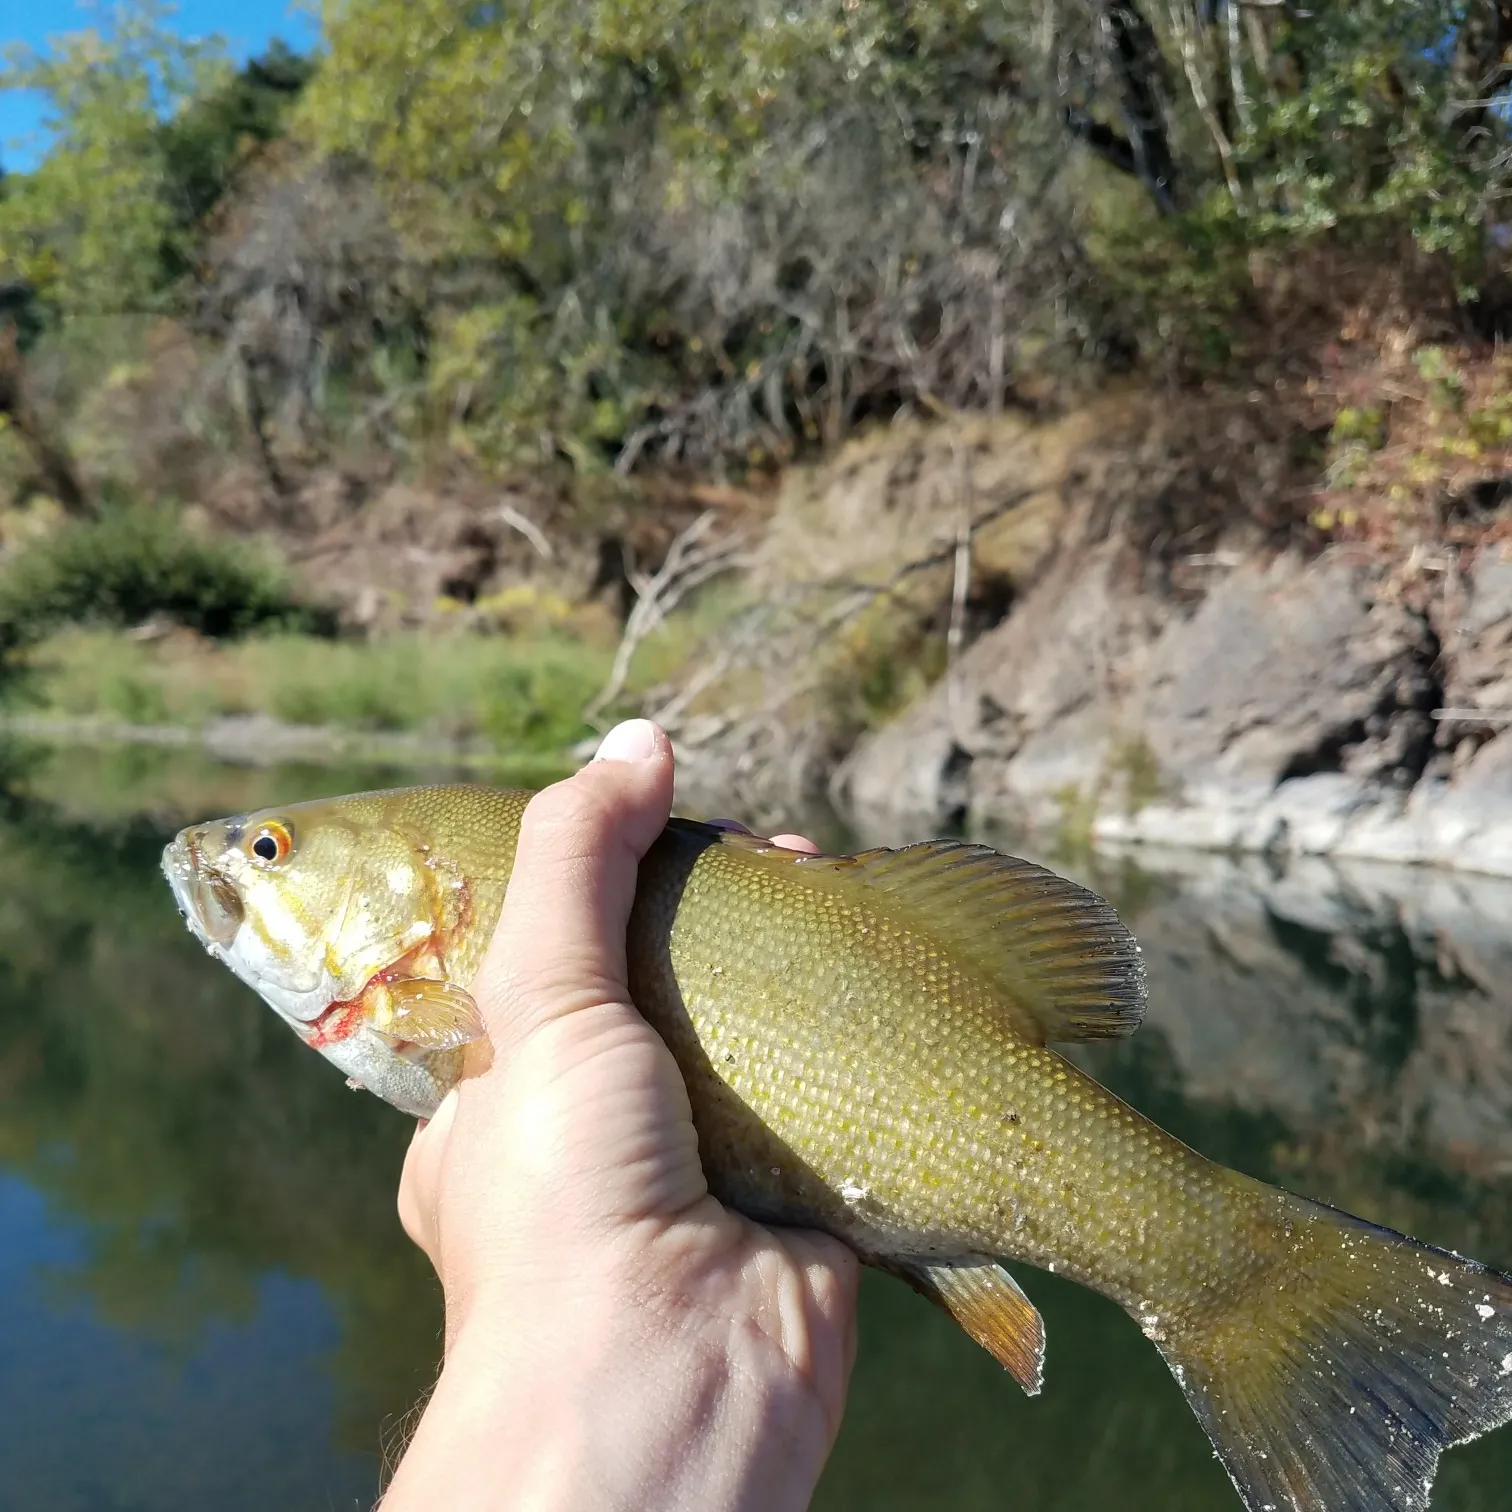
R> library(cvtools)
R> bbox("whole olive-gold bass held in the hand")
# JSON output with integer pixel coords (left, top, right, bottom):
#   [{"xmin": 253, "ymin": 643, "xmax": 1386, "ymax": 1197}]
[{"xmin": 163, "ymin": 786, "xmax": 1512, "ymax": 1512}]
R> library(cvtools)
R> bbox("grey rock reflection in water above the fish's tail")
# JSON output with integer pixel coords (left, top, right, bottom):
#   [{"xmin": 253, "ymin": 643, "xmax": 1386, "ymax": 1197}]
[{"xmin": 1095, "ymin": 853, "xmax": 1512, "ymax": 1266}]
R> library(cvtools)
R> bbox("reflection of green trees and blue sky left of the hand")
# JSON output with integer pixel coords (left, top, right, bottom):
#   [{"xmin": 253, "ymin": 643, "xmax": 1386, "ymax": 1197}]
[{"xmin": 0, "ymin": 746, "xmax": 438, "ymax": 1512}]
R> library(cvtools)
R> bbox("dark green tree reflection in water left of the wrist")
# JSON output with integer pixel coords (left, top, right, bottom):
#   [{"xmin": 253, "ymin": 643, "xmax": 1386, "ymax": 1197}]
[{"xmin": 0, "ymin": 768, "xmax": 440, "ymax": 1450}]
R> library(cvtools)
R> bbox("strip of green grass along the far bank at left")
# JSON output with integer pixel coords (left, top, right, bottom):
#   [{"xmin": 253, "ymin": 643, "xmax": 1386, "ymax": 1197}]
[{"xmin": 9, "ymin": 627, "xmax": 611, "ymax": 751}]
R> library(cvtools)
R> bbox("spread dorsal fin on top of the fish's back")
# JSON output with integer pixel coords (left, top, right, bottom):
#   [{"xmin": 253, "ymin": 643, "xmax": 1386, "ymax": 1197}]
[{"xmin": 795, "ymin": 841, "xmax": 1146, "ymax": 1042}]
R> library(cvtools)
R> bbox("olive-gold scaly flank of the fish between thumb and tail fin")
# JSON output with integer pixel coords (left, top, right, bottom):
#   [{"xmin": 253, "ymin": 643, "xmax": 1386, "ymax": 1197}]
[{"xmin": 631, "ymin": 816, "xmax": 1264, "ymax": 1308}]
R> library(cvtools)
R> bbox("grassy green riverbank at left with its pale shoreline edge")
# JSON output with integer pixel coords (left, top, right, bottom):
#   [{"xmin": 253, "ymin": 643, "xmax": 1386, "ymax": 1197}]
[{"xmin": 0, "ymin": 623, "xmax": 614, "ymax": 770}]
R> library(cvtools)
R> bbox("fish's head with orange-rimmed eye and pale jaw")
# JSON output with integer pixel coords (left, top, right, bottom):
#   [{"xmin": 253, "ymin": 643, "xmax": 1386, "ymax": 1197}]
[{"xmin": 163, "ymin": 795, "xmax": 470, "ymax": 1117}]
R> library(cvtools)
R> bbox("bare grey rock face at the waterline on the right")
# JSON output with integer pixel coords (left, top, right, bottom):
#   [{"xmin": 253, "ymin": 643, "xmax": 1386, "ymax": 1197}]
[{"xmin": 833, "ymin": 540, "xmax": 1512, "ymax": 874}]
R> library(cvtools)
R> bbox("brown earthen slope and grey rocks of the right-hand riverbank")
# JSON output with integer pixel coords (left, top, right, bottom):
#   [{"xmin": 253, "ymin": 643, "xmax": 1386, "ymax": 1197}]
[{"xmin": 644, "ymin": 373, "xmax": 1512, "ymax": 875}]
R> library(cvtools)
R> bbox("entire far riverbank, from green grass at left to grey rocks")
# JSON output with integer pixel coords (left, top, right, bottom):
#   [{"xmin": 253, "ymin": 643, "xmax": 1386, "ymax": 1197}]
[{"xmin": 17, "ymin": 392, "xmax": 1512, "ymax": 875}]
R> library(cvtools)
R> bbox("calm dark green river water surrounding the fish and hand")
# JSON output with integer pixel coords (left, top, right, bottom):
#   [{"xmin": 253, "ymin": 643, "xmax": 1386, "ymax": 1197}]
[{"xmin": 0, "ymin": 750, "xmax": 1512, "ymax": 1512}]
